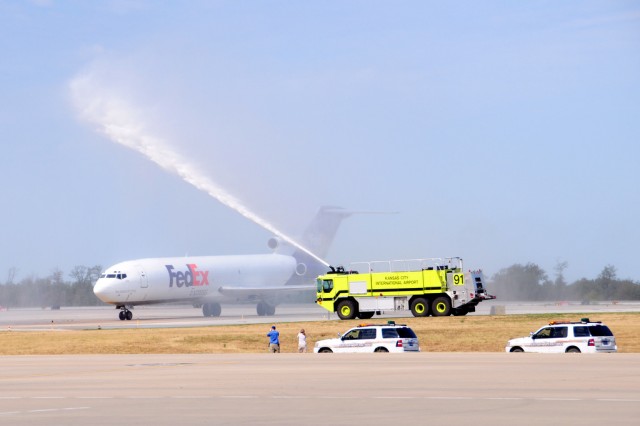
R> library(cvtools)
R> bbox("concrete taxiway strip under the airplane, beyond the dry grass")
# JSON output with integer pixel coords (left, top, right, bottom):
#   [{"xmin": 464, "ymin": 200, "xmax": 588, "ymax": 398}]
[{"xmin": 0, "ymin": 301, "xmax": 640, "ymax": 331}]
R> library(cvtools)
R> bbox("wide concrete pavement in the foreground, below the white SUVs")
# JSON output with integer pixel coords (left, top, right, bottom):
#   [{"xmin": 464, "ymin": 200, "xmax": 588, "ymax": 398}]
[{"xmin": 0, "ymin": 353, "xmax": 640, "ymax": 426}]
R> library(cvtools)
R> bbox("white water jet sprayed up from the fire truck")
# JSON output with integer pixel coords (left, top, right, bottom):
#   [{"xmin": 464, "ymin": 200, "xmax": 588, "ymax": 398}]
[{"xmin": 70, "ymin": 74, "xmax": 329, "ymax": 266}]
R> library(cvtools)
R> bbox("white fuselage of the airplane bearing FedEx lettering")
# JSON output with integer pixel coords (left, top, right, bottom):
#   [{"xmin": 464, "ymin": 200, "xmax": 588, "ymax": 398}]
[{"xmin": 94, "ymin": 254, "xmax": 296, "ymax": 305}]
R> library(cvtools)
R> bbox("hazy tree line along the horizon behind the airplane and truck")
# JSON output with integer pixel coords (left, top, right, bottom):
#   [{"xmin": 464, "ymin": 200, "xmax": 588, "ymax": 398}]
[{"xmin": 0, "ymin": 262, "xmax": 640, "ymax": 308}]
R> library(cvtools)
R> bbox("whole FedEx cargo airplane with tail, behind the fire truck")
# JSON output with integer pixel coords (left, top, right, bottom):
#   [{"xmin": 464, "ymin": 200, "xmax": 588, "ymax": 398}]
[{"xmin": 93, "ymin": 206, "xmax": 352, "ymax": 320}]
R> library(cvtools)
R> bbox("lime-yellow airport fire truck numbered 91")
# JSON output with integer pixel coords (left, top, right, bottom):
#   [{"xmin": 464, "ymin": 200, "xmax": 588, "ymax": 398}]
[{"xmin": 316, "ymin": 257, "xmax": 495, "ymax": 319}]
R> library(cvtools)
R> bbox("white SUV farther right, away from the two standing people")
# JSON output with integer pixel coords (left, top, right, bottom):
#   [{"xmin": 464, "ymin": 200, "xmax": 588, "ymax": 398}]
[{"xmin": 505, "ymin": 318, "xmax": 618, "ymax": 353}]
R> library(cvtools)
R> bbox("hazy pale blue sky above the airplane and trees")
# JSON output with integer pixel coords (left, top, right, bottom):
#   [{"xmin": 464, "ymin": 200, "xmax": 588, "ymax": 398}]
[{"xmin": 0, "ymin": 0, "xmax": 640, "ymax": 282}]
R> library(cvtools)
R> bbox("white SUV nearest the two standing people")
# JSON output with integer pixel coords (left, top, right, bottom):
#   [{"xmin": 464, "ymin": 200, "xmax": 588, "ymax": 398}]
[{"xmin": 313, "ymin": 321, "xmax": 420, "ymax": 353}]
